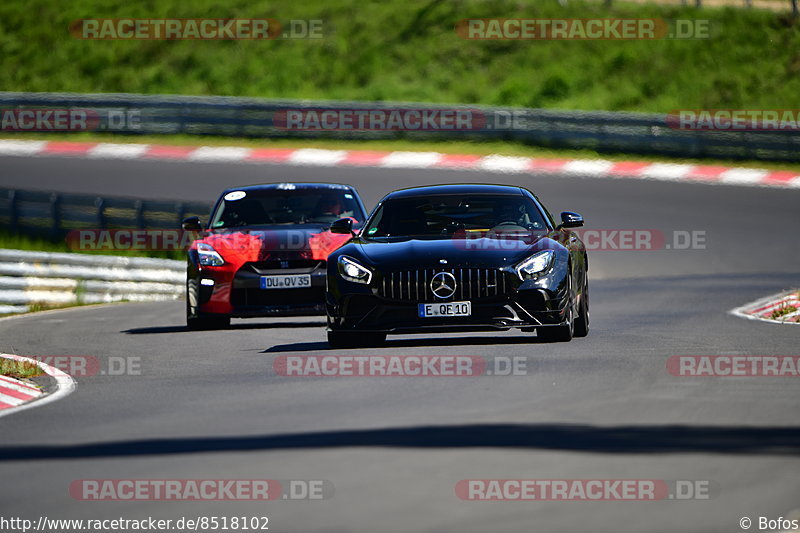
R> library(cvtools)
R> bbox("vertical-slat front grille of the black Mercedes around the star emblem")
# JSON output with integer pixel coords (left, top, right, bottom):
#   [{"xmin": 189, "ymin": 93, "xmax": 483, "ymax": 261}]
[{"xmin": 377, "ymin": 268, "xmax": 510, "ymax": 302}]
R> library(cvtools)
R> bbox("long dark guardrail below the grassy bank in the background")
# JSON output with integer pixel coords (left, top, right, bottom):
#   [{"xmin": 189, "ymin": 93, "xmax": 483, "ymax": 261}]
[{"xmin": 0, "ymin": 92, "xmax": 800, "ymax": 161}]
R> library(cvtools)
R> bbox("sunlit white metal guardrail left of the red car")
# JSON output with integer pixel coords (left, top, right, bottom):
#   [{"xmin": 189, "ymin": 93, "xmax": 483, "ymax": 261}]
[{"xmin": 0, "ymin": 249, "xmax": 186, "ymax": 314}]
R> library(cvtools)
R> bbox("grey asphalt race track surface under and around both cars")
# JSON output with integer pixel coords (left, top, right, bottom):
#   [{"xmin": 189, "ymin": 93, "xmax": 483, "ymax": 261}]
[{"xmin": 0, "ymin": 152, "xmax": 800, "ymax": 533}]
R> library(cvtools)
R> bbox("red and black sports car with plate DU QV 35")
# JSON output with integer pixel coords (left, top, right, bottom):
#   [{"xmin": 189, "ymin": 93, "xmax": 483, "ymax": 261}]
[{"xmin": 183, "ymin": 183, "xmax": 366, "ymax": 329}]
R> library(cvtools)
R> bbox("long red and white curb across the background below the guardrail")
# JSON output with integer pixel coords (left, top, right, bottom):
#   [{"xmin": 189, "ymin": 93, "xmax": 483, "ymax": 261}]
[{"xmin": 0, "ymin": 140, "xmax": 800, "ymax": 188}]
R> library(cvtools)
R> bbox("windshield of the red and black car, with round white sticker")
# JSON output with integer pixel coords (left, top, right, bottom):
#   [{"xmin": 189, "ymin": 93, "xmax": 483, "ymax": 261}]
[{"xmin": 211, "ymin": 186, "xmax": 364, "ymax": 229}]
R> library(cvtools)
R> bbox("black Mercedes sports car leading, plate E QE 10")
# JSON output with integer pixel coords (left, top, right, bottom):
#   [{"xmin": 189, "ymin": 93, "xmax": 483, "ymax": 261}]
[{"xmin": 326, "ymin": 185, "xmax": 589, "ymax": 347}]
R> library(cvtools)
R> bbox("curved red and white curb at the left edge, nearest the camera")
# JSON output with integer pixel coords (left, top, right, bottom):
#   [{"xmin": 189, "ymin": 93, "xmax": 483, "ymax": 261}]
[{"xmin": 0, "ymin": 353, "xmax": 76, "ymax": 417}]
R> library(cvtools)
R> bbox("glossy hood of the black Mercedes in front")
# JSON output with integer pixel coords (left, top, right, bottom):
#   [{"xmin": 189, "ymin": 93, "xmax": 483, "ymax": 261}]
[{"xmin": 357, "ymin": 237, "xmax": 554, "ymax": 270}]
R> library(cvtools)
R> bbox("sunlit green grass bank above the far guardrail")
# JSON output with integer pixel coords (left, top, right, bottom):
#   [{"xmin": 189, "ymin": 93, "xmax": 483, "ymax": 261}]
[{"xmin": 0, "ymin": 0, "xmax": 800, "ymax": 112}]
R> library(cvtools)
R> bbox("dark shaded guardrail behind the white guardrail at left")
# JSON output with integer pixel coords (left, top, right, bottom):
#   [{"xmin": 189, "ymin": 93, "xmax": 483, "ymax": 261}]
[{"xmin": 0, "ymin": 188, "xmax": 211, "ymax": 239}]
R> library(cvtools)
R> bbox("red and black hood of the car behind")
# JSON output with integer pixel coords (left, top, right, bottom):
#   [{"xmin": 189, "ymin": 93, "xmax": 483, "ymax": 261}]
[{"xmin": 195, "ymin": 224, "xmax": 350, "ymax": 261}]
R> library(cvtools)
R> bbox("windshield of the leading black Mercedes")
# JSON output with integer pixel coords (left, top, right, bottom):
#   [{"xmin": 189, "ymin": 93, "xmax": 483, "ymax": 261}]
[{"xmin": 362, "ymin": 194, "xmax": 547, "ymax": 239}]
